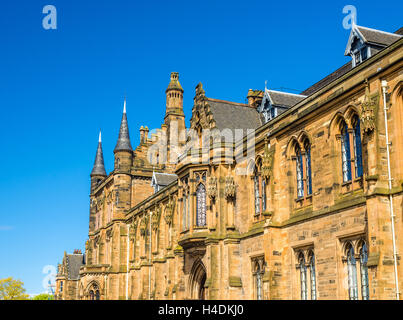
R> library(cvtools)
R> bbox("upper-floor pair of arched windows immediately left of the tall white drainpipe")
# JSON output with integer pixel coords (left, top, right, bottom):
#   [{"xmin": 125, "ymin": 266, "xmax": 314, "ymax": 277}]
[{"xmin": 340, "ymin": 115, "xmax": 363, "ymax": 182}]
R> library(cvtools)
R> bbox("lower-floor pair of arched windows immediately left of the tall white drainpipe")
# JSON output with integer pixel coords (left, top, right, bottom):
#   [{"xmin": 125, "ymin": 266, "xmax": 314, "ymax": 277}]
[{"xmin": 345, "ymin": 241, "xmax": 369, "ymax": 300}]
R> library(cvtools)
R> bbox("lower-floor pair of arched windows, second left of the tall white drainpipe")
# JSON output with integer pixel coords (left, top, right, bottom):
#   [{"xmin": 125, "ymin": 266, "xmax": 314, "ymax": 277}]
[{"xmin": 297, "ymin": 250, "xmax": 316, "ymax": 300}]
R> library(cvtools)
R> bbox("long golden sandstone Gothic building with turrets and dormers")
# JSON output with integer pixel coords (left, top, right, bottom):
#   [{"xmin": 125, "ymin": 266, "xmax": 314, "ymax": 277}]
[{"xmin": 57, "ymin": 25, "xmax": 403, "ymax": 300}]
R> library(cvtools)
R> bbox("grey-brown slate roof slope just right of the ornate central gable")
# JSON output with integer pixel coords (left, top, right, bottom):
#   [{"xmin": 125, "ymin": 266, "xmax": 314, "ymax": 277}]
[{"xmin": 206, "ymin": 98, "xmax": 263, "ymax": 134}]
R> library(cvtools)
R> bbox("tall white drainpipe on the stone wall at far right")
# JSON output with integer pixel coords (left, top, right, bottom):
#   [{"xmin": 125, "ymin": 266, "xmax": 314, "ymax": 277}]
[{"xmin": 381, "ymin": 80, "xmax": 400, "ymax": 300}]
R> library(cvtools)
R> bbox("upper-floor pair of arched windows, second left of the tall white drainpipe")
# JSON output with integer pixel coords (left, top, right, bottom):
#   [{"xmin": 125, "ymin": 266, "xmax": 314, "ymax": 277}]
[{"xmin": 294, "ymin": 139, "xmax": 312, "ymax": 199}]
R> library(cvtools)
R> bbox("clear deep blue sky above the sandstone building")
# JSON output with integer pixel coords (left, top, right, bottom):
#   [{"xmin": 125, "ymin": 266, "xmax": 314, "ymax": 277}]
[{"xmin": 0, "ymin": 0, "xmax": 403, "ymax": 293}]
